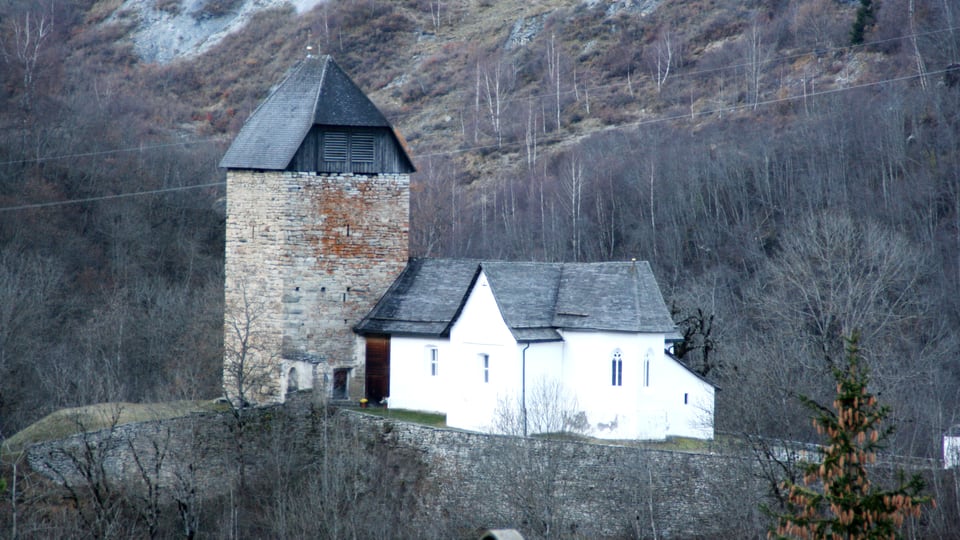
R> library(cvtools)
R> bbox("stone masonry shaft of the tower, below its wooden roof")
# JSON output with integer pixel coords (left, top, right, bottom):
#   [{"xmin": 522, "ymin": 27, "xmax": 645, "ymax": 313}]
[{"xmin": 224, "ymin": 170, "xmax": 410, "ymax": 402}]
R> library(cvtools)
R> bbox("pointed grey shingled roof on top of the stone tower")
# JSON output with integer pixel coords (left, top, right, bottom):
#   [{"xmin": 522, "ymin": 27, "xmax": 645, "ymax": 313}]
[{"xmin": 220, "ymin": 56, "xmax": 409, "ymax": 170}]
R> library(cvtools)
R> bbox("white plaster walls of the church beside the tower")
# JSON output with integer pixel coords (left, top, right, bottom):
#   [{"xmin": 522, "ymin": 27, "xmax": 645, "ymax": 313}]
[{"xmin": 408, "ymin": 273, "xmax": 714, "ymax": 440}]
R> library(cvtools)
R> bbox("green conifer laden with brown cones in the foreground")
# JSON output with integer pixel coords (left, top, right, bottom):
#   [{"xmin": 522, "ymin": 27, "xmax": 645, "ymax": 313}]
[{"xmin": 770, "ymin": 334, "xmax": 933, "ymax": 540}]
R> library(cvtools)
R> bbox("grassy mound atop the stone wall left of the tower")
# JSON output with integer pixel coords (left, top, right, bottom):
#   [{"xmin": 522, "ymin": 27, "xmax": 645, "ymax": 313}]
[{"xmin": 0, "ymin": 400, "xmax": 220, "ymax": 460}]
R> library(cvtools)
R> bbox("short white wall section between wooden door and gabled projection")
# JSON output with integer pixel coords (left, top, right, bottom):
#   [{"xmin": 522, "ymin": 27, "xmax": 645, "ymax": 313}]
[{"xmin": 390, "ymin": 336, "xmax": 453, "ymax": 413}]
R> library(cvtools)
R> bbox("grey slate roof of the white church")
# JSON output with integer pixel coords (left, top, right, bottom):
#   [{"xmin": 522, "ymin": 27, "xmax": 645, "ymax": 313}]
[{"xmin": 355, "ymin": 259, "xmax": 676, "ymax": 342}]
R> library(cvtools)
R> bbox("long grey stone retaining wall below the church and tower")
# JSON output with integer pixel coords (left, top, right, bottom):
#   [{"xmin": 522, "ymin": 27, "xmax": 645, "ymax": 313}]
[{"xmin": 28, "ymin": 393, "xmax": 766, "ymax": 538}]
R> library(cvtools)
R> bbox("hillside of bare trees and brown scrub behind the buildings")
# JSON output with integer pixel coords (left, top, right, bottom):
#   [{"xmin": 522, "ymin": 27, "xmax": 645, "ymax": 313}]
[{"xmin": 0, "ymin": 0, "xmax": 960, "ymax": 464}]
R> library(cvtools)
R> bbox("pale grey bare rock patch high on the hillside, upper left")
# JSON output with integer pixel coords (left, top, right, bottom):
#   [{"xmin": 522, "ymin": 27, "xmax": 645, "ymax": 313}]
[{"xmin": 102, "ymin": 0, "xmax": 324, "ymax": 64}]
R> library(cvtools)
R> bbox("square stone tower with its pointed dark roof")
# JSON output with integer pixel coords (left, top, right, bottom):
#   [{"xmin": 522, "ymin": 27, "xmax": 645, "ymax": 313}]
[{"xmin": 220, "ymin": 56, "xmax": 414, "ymax": 403}]
